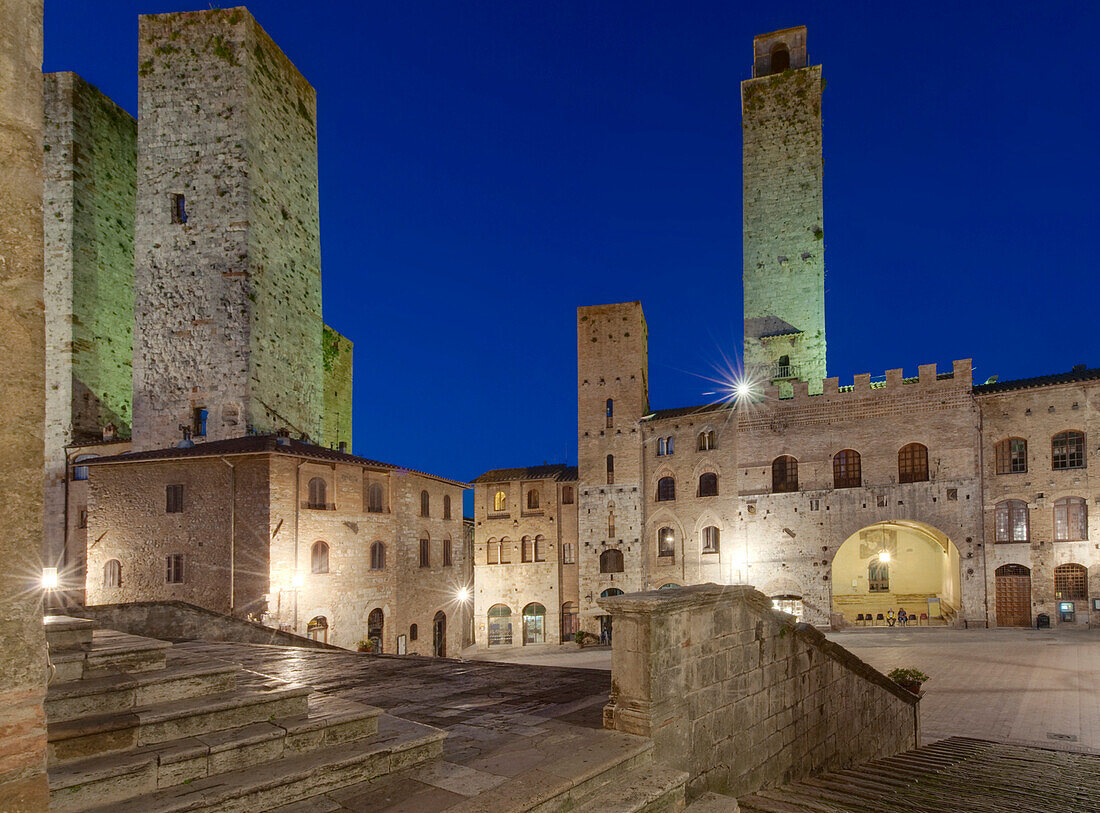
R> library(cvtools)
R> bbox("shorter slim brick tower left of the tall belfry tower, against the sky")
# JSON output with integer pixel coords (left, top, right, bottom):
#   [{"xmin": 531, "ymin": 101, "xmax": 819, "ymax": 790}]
[{"xmin": 576, "ymin": 303, "xmax": 649, "ymax": 634}]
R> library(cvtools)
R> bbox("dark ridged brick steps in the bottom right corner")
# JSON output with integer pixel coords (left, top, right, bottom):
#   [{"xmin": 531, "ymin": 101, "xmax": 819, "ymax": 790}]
[{"xmin": 734, "ymin": 737, "xmax": 1100, "ymax": 813}]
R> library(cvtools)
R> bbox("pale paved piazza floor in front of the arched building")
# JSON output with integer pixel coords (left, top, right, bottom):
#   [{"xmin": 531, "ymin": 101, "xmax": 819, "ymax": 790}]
[{"xmin": 468, "ymin": 627, "xmax": 1100, "ymax": 754}]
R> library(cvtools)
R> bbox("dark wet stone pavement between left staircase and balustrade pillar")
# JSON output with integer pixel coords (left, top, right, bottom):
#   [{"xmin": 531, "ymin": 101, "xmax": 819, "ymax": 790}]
[{"xmin": 177, "ymin": 641, "xmax": 619, "ymax": 813}]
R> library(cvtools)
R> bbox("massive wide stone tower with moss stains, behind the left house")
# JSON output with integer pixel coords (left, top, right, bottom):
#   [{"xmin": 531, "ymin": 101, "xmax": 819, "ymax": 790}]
[{"xmin": 133, "ymin": 9, "xmax": 325, "ymax": 450}]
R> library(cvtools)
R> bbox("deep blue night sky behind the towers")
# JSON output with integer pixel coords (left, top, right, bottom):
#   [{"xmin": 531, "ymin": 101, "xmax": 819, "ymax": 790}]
[{"xmin": 45, "ymin": 0, "xmax": 1100, "ymax": 508}]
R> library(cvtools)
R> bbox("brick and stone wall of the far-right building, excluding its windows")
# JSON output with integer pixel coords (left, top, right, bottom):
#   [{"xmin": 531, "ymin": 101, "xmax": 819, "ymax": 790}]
[{"xmin": 977, "ymin": 377, "xmax": 1100, "ymax": 625}]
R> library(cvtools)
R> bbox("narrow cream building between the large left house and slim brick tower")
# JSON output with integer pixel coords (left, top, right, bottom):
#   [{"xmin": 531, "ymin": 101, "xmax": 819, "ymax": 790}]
[{"xmin": 472, "ymin": 464, "xmax": 580, "ymax": 647}]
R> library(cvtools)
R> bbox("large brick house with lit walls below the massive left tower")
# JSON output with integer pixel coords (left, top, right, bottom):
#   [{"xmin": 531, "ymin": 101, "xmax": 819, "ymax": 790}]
[{"xmin": 87, "ymin": 436, "xmax": 472, "ymax": 656}]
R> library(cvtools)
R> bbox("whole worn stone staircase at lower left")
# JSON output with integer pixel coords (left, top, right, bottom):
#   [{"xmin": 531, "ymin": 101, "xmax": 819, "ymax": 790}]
[{"xmin": 45, "ymin": 616, "xmax": 446, "ymax": 813}]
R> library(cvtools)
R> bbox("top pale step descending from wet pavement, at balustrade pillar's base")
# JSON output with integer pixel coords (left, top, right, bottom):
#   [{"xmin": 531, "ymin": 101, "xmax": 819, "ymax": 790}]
[{"xmin": 447, "ymin": 729, "xmax": 653, "ymax": 813}]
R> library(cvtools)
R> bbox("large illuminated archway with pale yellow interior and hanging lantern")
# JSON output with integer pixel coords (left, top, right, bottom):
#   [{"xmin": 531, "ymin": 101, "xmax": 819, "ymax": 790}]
[{"xmin": 829, "ymin": 519, "xmax": 960, "ymax": 624}]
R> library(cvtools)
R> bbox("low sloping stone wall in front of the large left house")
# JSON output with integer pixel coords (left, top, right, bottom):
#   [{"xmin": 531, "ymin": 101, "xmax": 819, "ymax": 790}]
[{"xmin": 75, "ymin": 602, "xmax": 340, "ymax": 649}]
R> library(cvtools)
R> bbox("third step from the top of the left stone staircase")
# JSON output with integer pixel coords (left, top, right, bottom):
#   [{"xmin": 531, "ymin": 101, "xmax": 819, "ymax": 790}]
[{"xmin": 46, "ymin": 650, "xmax": 241, "ymax": 722}]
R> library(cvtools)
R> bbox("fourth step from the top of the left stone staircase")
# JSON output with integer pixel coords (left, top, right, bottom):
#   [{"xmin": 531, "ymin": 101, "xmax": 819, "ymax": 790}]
[{"xmin": 46, "ymin": 680, "xmax": 310, "ymax": 768}]
